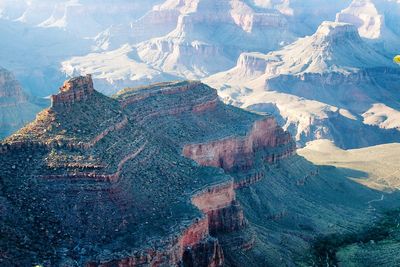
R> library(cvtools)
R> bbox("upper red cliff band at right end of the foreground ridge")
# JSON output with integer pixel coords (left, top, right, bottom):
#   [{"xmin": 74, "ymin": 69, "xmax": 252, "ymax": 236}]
[{"xmin": 183, "ymin": 118, "xmax": 295, "ymax": 171}]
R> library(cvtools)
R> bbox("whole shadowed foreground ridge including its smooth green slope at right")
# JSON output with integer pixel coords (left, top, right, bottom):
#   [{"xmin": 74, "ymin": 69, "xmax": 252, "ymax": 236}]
[{"xmin": 0, "ymin": 75, "xmax": 396, "ymax": 266}]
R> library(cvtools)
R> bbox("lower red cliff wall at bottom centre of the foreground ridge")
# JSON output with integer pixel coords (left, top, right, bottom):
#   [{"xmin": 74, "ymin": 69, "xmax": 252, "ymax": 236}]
[{"xmin": 87, "ymin": 181, "xmax": 239, "ymax": 267}]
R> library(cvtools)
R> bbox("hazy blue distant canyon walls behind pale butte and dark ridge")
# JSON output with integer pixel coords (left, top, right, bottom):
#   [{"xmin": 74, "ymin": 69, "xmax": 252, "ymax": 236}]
[{"xmin": 0, "ymin": 0, "xmax": 399, "ymax": 100}]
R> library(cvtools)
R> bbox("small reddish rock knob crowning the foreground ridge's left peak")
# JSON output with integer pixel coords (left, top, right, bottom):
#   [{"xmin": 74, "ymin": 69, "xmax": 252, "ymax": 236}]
[{"xmin": 51, "ymin": 74, "xmax": 94, "ymax": 107}]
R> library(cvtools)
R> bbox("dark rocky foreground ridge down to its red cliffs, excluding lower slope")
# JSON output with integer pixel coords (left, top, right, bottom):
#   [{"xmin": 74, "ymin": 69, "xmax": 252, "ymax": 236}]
[{"xmin": 0, "ymin": 76, "xmax": 294, "ymax": 266}]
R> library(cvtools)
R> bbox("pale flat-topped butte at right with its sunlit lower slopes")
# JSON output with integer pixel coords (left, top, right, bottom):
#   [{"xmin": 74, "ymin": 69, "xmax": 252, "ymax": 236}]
[{"xmin": 205, "ymin": 22, "xmax": 400, "ymax": 147}]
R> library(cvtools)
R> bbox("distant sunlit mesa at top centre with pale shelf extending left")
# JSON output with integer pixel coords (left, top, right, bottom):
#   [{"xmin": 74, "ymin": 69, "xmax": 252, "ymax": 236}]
[{"xmin": 62, "ymin": 0, "xmax": 295, "ymax": 94}]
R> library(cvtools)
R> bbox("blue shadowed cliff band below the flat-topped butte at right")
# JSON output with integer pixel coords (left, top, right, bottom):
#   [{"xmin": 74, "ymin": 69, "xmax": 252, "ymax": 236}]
[{"xmin": 265, "ymin": 67, "xmax": 400, "ymax": 114}]
